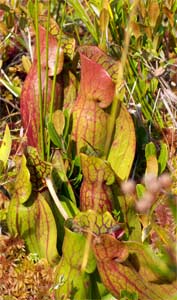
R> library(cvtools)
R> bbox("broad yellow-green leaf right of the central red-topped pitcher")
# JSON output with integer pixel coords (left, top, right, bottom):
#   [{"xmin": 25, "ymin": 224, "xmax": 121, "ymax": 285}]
[{"xmin": 108, "ymin": 105, "xmax": 136, "ymax": 180}]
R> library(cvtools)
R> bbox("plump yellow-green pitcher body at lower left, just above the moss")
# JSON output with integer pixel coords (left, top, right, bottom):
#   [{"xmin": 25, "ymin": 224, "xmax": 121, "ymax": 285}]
[{"xmin": 7, "ymin": 193, "xmax": 59, "ymax": 265}]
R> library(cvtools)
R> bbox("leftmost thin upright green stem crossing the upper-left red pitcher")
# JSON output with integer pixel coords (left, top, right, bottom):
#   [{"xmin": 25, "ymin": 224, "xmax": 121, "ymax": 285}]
[{"xmin": 35, "ymin": 0, "xmax": 44, "ymax": 159}]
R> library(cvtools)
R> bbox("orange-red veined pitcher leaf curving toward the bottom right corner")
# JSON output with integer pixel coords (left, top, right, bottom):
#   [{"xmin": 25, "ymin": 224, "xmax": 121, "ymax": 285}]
[{"xmin": 92, "ymin": 234, "xmax": 176, "ymax": 300}]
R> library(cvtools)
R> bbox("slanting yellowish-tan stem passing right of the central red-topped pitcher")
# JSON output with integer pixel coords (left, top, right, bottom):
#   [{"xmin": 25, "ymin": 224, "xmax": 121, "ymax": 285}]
[{"xmin": 104, "ymin": 0, "xmax": 139, "ymax": 158}]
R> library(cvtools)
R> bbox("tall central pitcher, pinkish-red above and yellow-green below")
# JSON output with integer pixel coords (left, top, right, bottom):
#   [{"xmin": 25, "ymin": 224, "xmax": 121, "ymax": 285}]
[{"xmin": 72, "ymin": 47, "xmax": 115, "ymax": 152}]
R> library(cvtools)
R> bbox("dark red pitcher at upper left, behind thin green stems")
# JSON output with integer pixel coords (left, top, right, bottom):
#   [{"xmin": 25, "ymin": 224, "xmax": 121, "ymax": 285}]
[{"xmin": 20, "ymin": 26, "xmax": 63, "ymax": 150}]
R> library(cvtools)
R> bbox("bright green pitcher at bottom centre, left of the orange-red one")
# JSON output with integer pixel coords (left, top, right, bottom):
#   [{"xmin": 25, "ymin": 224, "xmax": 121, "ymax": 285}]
[{"xmin": 55, "ymin": 228, "xmax": 96, "ymax": 300}]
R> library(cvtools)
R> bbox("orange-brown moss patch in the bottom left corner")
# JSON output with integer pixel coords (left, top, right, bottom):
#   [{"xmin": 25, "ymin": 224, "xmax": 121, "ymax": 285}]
[{"xmin": 0, "ymin": 235, "xmax": 54, "ymax": 300}]
